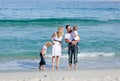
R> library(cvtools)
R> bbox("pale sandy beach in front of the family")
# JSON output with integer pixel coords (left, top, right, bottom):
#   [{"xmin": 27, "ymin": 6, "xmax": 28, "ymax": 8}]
[{"xmin": 0, "ymin": 69, "xmax": 120, "ymax": 81}]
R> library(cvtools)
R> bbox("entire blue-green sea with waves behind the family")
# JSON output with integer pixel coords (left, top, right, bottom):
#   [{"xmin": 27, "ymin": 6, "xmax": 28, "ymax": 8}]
[{"xmin": 0, "ymin": 0, "xmax": 120, "ymax": 71}]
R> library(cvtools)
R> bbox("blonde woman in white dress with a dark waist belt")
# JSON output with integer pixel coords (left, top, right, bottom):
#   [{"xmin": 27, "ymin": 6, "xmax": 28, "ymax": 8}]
[{"xmin": 52, "ymin": 26, "xmax": 63, "ymax": 70}]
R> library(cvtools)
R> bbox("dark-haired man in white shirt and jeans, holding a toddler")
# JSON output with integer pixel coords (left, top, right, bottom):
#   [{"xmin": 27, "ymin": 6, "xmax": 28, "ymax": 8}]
[{"xmin": 65, "ymin": 25, "xmax": 80, "ymax": 69}]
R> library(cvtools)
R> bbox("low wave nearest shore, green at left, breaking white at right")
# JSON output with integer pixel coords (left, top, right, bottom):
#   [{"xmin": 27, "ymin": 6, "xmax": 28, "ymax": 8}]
[{"xmin": 0, "ymin": 52, "xmax": 120, "ymax": 60}]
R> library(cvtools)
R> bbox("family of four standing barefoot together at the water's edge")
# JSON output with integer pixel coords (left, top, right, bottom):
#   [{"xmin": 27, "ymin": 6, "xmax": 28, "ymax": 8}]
[{"xmin": 39, "ymin": 25, "xmax": 80, "ymax": 70}]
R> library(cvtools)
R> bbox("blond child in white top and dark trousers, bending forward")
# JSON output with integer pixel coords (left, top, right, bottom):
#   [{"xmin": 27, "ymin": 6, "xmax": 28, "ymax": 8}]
[{"xmin": 39, "ymin": 42, "xmax": 52, "ymax": 70}]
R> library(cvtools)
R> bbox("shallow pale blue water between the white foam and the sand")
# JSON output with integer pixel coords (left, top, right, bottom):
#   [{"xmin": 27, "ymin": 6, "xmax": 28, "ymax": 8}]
[{"xmin": 0, "ymin": 57, "xmax": 120, "ymax": 72}]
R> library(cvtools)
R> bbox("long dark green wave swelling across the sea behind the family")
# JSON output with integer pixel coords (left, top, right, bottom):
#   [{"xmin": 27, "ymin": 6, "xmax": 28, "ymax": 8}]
[{"xmin": 0, "ymin": 18, "xmax": 120, "ymax": 25}]
